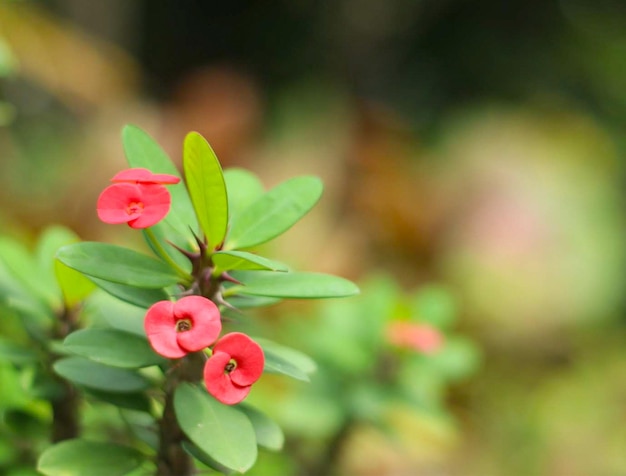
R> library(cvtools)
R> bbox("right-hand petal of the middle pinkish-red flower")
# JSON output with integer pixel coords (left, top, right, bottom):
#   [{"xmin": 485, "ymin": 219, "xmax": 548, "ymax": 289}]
[{"xmin": 174, "ymin": 296, "xmax": 222, "ymax": 352}]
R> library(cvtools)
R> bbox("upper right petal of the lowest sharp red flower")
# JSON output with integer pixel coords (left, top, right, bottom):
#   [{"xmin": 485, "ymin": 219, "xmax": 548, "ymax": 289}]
[{"xmin": 213, "ymin": 332, "xmax": 265, "ymax": 386}]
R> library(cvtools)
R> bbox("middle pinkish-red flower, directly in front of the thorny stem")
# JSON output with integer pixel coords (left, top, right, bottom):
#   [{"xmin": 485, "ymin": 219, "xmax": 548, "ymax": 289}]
[{"xmin": 144, "ymin": 296, "xmax": 222, "ymax": 359}]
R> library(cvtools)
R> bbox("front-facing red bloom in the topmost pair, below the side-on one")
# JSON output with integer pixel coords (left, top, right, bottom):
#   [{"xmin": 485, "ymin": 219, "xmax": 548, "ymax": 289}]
[{"xmin": 96, "ymin": 183, "xmax": 172, "ymax": 228}]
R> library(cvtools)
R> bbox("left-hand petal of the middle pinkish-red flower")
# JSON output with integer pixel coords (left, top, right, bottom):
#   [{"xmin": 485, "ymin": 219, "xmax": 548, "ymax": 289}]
[{"xmin": 144, "ymin": 301, "xmax": 187, "ymax": 359}]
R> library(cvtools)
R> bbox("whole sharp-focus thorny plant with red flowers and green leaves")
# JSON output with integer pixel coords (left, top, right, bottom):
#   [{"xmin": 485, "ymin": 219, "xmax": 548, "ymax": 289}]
[{"xmin": 22, "ymin": 126, "xmax": 358, "ymax": 476}]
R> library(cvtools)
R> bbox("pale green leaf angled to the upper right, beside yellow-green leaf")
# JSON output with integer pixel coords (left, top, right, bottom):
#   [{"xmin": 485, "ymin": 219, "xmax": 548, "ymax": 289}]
[{"xmin": 224, "ymin": 176, "xmax": 324, "ymax": 249}]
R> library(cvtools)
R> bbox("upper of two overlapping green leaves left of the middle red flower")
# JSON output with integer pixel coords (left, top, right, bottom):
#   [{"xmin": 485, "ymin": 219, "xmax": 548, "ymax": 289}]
[{"xmin": 63, "ymin": 329, "xmax": 165, "ymax": 369}]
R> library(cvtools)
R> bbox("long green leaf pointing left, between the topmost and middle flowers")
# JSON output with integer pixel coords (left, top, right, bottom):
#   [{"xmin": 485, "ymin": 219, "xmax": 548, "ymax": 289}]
[{"xmin": 57, "ymin": 241, "xmax": 180, "ymax": 288}]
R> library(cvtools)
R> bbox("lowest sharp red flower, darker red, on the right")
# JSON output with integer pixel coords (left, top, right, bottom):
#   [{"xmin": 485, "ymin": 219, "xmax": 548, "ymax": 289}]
[{"xmin": 204, "ymin": 332, "xmax": 265, "ymax": 405}]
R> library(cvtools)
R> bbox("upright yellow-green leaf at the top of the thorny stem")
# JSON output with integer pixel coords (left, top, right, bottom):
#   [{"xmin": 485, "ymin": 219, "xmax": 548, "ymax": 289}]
[{"xmin": 183, "ymin": 132, "xmax": 228, "ymax": 250}]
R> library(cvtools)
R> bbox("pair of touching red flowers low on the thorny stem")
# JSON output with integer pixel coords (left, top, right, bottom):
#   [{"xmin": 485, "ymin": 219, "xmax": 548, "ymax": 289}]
[{"xmin": 144, "ymin": 296, "xmax": 265, "ymax": 405}]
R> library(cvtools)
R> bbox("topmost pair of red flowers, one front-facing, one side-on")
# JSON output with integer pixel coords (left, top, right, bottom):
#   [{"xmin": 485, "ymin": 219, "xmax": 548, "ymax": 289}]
[{"xmin": 97, "ymin": 168, "xmax": 180, "ymax": 228}]
